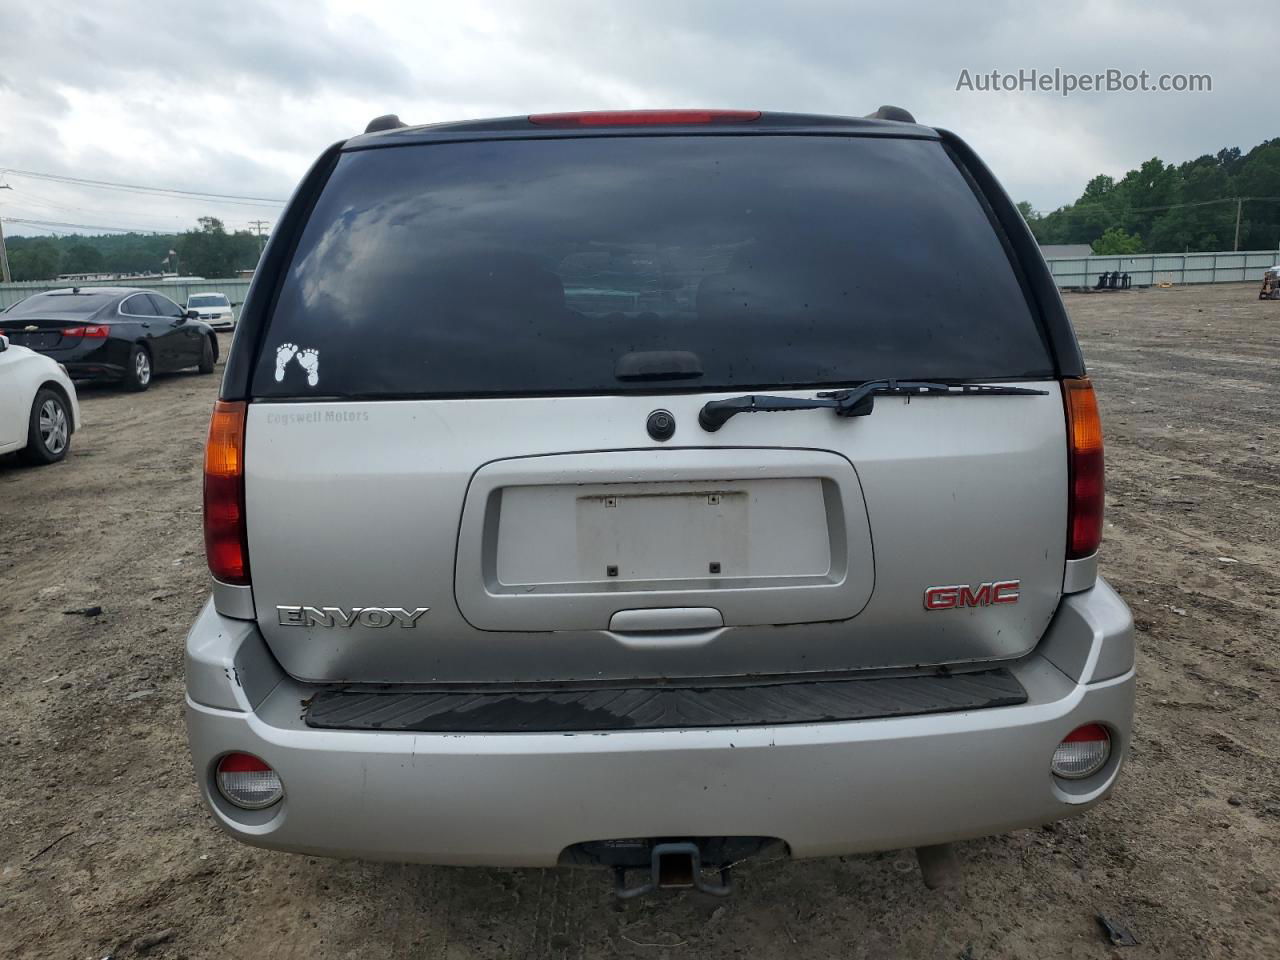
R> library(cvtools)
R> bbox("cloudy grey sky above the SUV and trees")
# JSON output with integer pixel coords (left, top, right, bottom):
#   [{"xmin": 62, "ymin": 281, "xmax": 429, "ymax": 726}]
[{"xmin": 0, "ymin": 0, "xmax": 1280, "ymax": 234}]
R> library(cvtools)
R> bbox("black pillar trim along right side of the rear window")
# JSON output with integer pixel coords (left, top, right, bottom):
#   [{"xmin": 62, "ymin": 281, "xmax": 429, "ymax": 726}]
[{"xmin": 938, "ymin": 128, "xmax": 1084, "ymax": 376}]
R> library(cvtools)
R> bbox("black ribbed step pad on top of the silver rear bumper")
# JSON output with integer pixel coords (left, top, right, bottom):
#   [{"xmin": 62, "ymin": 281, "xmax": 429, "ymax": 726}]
[{"xmin": 303, "ymin": 668, "xmax": 1027, "ymax": 733}]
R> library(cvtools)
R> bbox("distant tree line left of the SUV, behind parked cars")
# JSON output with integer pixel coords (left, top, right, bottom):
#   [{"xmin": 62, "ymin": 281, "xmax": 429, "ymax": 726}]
[{"xmin": 5, "ymin": 216, "xmax": 261, "ymax": 280}]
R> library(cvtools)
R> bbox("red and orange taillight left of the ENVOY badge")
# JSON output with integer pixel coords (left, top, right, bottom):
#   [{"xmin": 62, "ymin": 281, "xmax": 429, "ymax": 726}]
[{"xmin": 205, "ymin": 401, "xmax": 250, "ymax": 585}]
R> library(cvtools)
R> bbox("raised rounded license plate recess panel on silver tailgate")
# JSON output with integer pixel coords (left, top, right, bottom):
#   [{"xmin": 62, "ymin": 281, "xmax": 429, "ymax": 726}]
[{"xmin": 456, "ymin": 449, "xmax": 873, "ymax": 631}]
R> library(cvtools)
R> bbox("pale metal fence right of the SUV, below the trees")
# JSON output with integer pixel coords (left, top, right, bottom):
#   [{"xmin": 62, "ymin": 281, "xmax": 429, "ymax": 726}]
[{"xmin": 1046, "ymin": 250, "xmax": 1280, "ymax": 287}]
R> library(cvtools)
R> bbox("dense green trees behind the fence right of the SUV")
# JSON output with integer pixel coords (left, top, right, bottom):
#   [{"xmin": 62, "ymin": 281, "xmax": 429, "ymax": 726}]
[{"xmin": 1019, "ymin": 138, "xmax": 1280, "ymax": 253}]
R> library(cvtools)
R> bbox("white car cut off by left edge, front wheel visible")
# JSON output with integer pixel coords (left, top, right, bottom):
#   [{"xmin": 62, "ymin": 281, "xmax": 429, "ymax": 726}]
[{"xmin": 0, "ymin": 335, "xmax": 81, "ymax": 463}]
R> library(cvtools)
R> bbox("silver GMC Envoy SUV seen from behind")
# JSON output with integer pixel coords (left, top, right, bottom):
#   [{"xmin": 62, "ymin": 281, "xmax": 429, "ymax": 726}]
[{"xmin": 187, "ymin": 108, "xmax": 1134, "ymax": 897}]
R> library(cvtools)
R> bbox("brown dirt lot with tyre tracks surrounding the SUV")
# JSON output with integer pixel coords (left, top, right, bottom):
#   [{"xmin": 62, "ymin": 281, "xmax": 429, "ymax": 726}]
[{"xmin": 0, "ymin": 284, "xmax": 1280, "ymax": 960}]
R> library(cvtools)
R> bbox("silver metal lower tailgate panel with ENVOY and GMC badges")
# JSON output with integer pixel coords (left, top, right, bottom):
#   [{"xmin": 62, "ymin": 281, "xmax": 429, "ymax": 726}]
[{"xmin": 240, "ymin": 381, "xmax": 1082, "ymax": 682}]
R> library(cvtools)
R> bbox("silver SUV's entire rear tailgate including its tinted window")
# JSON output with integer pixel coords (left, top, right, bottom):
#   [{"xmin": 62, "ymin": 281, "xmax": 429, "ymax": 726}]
[{"xmin": 237, "ymin": 128, "xmax": 1068, "ymax": 682}]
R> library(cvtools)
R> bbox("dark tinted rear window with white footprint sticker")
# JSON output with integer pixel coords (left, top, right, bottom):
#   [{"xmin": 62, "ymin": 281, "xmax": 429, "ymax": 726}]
[{"xmin": 253, "ymin": 136, "xmax": 1052, "ymax": 397}]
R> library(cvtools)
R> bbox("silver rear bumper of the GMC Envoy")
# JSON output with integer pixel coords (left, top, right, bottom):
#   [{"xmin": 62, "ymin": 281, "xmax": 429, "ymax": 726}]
[{"xmin": 187, "ymin": 581, "xmax": 1134, "ymax": 867}]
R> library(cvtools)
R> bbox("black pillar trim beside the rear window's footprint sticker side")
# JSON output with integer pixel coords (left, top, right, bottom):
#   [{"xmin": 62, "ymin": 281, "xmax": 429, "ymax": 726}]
[{"xmin": 218, "ymin": 141, "xmax": 347, "ymax": 401}]
